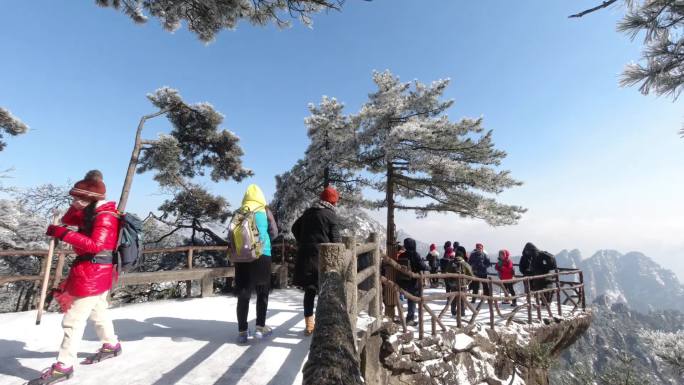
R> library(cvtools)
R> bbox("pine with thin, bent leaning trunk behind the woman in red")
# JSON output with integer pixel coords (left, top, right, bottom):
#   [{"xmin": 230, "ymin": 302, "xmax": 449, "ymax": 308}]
[{"xmin": 119, "ymin": 87, "xmax": 252, "ymax": 243}]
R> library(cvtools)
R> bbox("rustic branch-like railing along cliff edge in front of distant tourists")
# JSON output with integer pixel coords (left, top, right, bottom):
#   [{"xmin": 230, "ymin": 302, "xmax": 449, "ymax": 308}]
[{"xmin": 382, "ymin": 257, "xmax": 586, "ymax": 338}]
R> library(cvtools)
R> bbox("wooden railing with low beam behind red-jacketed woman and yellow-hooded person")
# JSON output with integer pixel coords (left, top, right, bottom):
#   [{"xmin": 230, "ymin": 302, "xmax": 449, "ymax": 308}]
[{"xmin": 0, "ymin": 246, "xmax": 287, "ymax": 310}]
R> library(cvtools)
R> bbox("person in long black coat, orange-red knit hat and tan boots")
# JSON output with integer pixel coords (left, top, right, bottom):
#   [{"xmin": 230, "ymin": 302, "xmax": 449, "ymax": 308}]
[{"xmin": 292, "ymin": 187, "xmax": 342, "ymax": 336}]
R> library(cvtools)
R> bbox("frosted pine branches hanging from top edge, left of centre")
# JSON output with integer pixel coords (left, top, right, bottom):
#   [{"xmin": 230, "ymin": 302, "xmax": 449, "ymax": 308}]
[{"xmin": 95, "ymin": 0, "xmax": 343, "ymax": 42}]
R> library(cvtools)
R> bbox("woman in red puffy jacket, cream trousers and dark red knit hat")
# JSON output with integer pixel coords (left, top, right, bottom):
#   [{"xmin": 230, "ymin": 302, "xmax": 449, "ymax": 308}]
[{"xmin": 29, "ymin": 170, "xmax": 121, "ymax": 385}]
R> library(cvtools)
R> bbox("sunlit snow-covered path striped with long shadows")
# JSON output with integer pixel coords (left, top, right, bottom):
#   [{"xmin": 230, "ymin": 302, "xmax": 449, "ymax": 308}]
[{"xmin": 0, "ymin": 289, "xmax": 310, "ymax": 385}]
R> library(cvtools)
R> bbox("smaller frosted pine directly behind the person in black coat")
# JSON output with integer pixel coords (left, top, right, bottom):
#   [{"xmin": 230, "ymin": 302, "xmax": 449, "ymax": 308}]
[{"xmin": 272, "ymin": 96, "xmax": 365, "ymax": 232}]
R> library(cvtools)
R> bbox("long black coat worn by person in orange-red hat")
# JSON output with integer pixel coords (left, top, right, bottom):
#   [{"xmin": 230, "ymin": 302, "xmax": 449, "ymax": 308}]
[{"xmin": 292, "ymin": 202, "xmax": 342, "ymax": 288}]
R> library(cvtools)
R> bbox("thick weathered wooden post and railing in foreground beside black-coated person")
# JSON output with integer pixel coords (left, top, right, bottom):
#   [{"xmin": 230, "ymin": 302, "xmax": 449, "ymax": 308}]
[{"xmin": 303, "ymin": 234, "xmax": 382, "ymax": 385}]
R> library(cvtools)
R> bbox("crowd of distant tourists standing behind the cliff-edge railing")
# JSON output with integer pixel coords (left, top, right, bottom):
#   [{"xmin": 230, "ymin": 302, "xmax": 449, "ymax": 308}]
[{"xmin": 384, "ymin": 238, "xmax": 557, "ymax": 326}]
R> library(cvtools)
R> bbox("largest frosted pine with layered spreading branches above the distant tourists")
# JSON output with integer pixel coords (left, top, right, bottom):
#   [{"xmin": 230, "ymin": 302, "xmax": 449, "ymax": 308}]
[{"xmin": 355, "ymin": 71, "xmax": 525, "ymax": 250}]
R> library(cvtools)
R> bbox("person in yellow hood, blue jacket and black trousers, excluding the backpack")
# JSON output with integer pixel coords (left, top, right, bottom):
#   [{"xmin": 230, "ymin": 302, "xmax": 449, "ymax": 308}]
[{"xmin": 235, "ymin": 184, "xmax": 278, "ymax": 343}]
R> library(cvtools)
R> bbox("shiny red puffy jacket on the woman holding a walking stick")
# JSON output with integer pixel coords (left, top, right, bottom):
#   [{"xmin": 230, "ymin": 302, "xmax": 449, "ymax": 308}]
[{"xmin": 62, "ymin": 202, "xmax": 119, "ymax": 297}]
